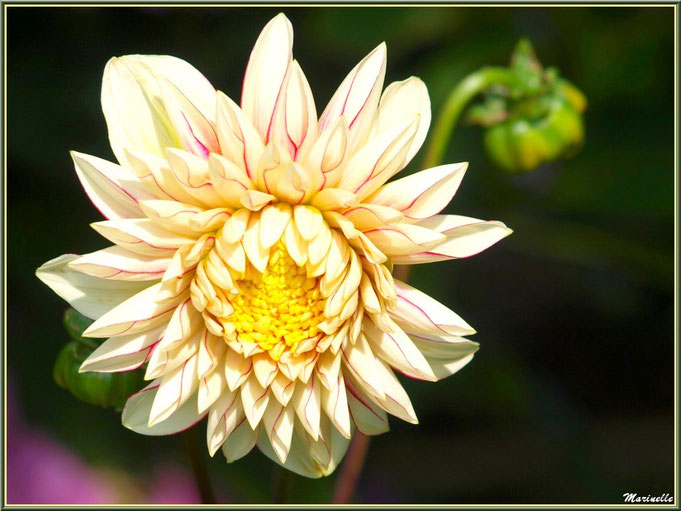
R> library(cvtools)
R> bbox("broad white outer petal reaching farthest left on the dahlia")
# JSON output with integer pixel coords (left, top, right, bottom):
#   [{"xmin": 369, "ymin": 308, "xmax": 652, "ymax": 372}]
[{"xmin": 36, "ymin": 254, "xmax": 149, "ymax": 319}]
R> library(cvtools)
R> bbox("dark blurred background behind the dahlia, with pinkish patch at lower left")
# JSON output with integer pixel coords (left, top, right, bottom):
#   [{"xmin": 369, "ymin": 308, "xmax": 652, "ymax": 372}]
[{"xmin": 5, "ymin": 6, "xmax": 674, "ymax": 504}]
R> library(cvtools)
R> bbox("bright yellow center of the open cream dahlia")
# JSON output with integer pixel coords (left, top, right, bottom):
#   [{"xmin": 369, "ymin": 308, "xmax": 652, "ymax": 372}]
[{"xmin": 230, "ymin": 242, "xmax": 324, "ymax": 360}]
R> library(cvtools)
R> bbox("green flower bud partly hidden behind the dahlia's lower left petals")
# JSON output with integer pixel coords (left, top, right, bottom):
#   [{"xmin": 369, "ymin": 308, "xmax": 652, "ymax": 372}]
[{"xmin": 53, "ymin": 309, "xmax": 144, "ymax": 409}]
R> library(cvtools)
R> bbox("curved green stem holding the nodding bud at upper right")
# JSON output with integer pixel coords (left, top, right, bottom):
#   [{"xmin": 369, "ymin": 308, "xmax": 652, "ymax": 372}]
[{"xmin": 423, "ymin": 67, "xmax": 515, "ymax": 169}]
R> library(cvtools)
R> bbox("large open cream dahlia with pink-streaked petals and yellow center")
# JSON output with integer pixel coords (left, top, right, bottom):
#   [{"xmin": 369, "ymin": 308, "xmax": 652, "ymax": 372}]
[{"xmin": 38, "ymin": 14, "xmax": 511, "ymax": 477}]
